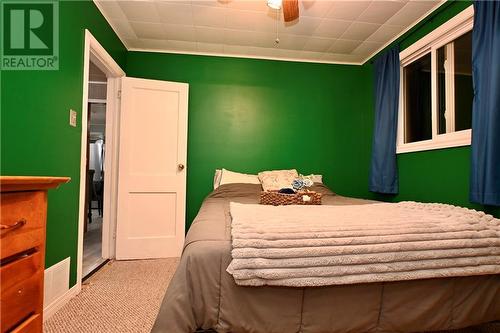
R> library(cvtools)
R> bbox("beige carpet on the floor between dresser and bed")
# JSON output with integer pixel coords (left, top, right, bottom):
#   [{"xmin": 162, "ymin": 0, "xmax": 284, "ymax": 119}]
[{"xmin": 44, "ymin": 258, "xmax": 179, "ymax": 333}]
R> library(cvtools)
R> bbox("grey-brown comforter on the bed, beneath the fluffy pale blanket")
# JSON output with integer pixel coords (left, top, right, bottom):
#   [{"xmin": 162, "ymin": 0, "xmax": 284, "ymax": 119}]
[{"xmin": 152, "ymin": 184, "xmax": 500, "ymax": 333}]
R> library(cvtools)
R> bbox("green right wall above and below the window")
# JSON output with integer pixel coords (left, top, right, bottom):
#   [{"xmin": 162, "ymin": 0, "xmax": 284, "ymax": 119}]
[{"xmin": 370, "ymin": 1, "xmax": 500, "ymax": 216}]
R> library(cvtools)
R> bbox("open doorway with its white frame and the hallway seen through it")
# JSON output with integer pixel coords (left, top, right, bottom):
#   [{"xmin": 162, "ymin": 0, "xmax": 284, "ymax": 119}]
[{"xmin": 75, "ymin": 30, "xmax": 125, "ymax": 292}]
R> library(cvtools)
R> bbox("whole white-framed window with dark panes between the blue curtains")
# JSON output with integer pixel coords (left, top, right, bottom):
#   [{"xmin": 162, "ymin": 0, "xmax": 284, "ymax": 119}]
[{"xmin": 397, "ymin": 6, "xmax": 473, "ymax": 153}]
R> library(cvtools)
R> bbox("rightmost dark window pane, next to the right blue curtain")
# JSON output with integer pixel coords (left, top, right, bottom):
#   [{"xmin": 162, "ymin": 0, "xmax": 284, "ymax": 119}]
[{"xmin": 453, "ymin": 32, "xmax": 474, "ymax": 131}]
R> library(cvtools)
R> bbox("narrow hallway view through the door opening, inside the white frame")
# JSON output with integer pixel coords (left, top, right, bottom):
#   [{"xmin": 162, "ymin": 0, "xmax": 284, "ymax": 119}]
[{"xmin": 82, "ymin": 60, "xmax": 107, "ymax": 279}]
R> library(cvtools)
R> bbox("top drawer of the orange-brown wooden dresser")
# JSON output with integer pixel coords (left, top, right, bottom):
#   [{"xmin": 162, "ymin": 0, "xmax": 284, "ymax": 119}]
[{"xmin": 0, "ymin": 191, "xmax": 47, "ymax": 259}]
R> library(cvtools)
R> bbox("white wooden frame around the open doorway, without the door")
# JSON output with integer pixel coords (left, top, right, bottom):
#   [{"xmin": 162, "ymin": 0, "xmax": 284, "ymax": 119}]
[{"xmin": 76, "ymin": 29, "xmax": 125, "ymax": 291}]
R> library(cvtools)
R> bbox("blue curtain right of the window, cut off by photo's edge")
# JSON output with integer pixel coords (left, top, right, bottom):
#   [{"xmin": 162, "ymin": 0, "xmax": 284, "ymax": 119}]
[{"xmin": 470, "ymin": 1, "xmax": 500, "ymax": 206}]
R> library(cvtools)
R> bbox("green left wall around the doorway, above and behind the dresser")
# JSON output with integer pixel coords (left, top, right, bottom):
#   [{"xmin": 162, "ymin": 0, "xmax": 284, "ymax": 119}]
[{"xmin": 0, "ymin": 1, "xmax": 126, "ymax": 286}]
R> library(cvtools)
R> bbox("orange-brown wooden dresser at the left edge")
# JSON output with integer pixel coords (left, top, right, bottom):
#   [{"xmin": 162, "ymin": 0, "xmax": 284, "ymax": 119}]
[{"xmin": 0, "ymin": 176, "xmax": 70, "ymax": 333}]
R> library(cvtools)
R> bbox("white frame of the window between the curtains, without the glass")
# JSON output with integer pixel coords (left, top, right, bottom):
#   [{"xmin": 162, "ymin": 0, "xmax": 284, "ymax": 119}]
[{"xmin": 396, "ymin": 6, "xmax": 474, "ymax": 154}]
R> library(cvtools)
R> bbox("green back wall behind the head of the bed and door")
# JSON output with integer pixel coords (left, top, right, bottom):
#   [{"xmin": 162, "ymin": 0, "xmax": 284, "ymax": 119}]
[{"xmin": 126, "ymin": 52, "xmax": 373, "ymax": 226}]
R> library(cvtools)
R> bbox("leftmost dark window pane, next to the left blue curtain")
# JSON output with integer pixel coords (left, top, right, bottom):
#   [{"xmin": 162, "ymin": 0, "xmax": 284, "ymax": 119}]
[{"xmin": 403, "ymin": 53, "xmax": 432, "ymax": 143}]
